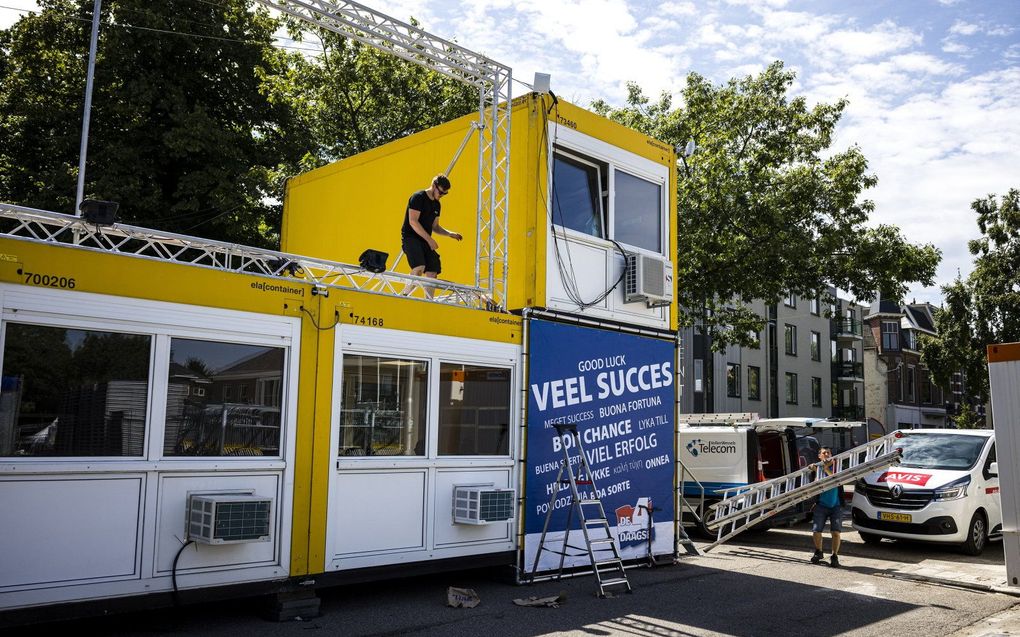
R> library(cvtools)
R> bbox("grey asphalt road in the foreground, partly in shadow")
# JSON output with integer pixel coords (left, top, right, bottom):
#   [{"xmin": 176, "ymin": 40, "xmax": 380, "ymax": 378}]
[{"xmin": 9, "ymin": 528, "xmax": 1020, "ymax": 637}]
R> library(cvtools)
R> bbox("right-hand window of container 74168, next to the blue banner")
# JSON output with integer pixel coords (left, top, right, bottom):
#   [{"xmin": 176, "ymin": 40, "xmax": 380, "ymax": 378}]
[{"xmin": 439, "ymin": 363, "xmax": 510, "ymax": 456}]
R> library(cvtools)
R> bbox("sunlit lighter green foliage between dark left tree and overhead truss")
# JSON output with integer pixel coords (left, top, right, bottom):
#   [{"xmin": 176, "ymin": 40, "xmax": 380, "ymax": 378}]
[{"xmin": 290, "ymin": 27, "xmax": 478, "ymax": 169}]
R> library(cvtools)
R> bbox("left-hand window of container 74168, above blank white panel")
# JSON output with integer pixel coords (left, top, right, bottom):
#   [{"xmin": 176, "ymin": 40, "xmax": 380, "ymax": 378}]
[{"xmin": 338, "ymin": 355, "xmax": 428, "ymax": 456}]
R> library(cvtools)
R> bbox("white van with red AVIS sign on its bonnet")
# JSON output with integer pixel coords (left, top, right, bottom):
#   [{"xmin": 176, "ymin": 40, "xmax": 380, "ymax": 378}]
[{"xmin": 852, "ymin": 429, "xmax": 1003, "ymax": 555}]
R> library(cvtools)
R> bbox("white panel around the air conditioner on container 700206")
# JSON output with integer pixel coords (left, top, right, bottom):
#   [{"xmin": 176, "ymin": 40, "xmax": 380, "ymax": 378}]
[{"xmin": 152, "ymin": 473, "xmax": 281, "ymax": 576}]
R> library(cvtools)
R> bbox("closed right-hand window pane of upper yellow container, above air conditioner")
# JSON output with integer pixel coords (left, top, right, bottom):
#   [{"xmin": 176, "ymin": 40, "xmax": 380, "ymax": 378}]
[{"xmin": 613, "ymin": 170, "xmax": 662, "ymax": 253}]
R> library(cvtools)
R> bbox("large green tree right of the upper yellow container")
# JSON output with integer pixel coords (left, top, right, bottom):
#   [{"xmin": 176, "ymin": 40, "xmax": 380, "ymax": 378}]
[{"xmin": 594, "ymin": 62, "xmax": 940, "ymax": 348}]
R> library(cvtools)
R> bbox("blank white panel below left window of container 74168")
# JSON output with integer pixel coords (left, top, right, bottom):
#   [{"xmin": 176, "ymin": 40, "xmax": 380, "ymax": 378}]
[{"xmin": 330, "ymin": 470, "xmax": 427, "ymax": 555}]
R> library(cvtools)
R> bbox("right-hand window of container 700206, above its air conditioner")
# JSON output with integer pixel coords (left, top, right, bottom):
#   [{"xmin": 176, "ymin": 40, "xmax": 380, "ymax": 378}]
[{"xmin": 163, "ymin": 338, "xmax": 285, "ymax": 457}]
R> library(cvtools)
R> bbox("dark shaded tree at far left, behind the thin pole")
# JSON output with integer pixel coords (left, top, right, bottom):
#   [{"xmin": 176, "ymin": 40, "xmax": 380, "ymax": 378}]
[{"xmin": 0, "ymin": 0, "xmax": 303, "ymax": 246}]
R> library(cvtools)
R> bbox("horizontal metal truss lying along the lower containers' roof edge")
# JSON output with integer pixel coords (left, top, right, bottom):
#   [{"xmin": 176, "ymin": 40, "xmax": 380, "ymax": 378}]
[{"xmin": 0, "ymin": 203, "xmax": 498, "ymax": 310}]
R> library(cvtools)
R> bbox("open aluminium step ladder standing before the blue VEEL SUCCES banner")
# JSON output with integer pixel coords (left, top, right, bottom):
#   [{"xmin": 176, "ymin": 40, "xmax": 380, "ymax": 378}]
[{"xmin": 528, "ymin": 424, "xmax": 632, "ymax": 597}]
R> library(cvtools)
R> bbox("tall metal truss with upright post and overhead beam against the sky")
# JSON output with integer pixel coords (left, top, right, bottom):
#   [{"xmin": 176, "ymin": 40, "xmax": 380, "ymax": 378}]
[{"xmin": 256, "ymin": 0, "xmax": 511, "ymax": 309}]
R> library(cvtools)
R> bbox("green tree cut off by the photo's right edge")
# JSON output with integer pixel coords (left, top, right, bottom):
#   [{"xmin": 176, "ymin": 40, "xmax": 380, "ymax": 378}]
[{"xmin": 921, "ymin": 189, "xmax": 1020, "ymax": 403}]
